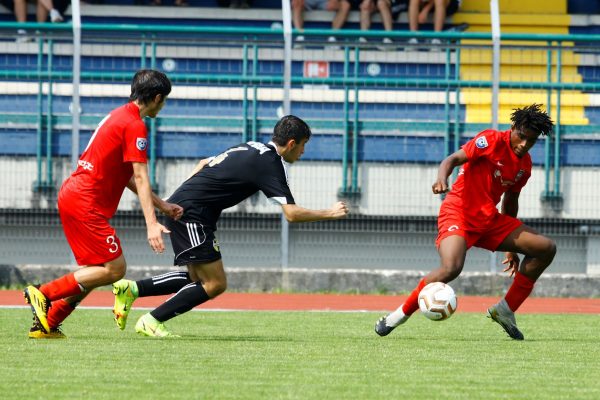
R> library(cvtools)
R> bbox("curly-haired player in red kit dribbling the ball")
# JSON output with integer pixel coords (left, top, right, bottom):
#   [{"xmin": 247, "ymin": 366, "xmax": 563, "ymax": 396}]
[{"xmin": 375, "ymin": 104, "xmax": 556, "ymax": 340}]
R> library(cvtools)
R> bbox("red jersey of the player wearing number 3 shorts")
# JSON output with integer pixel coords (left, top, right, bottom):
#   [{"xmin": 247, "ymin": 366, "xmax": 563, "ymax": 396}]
[{"xmin": 61, "ymin": 103, "xmax": 148, "ymax": 219}]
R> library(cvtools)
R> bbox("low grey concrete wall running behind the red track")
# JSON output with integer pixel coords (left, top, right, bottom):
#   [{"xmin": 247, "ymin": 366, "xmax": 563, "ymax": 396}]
[{"xmin": 0, "ymin": 265, "xmax": 600, "ymax": 298}]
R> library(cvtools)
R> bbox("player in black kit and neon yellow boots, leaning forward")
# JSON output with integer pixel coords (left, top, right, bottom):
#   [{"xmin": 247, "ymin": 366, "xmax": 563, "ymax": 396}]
[{"xmin": 113, "ymin": 115, "xmax": 348, "ymax": 337}]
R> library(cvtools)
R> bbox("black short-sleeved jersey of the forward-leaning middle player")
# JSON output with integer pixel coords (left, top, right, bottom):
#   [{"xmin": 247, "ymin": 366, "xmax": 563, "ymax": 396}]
[{"xmin": 168, "ymin": 142, "xmax": 295, "ymax": 229}]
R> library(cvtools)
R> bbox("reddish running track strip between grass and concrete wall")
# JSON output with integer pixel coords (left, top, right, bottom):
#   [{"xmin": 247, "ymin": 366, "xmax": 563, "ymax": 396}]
[{"xmin": 0, "ymin": 290, "xmax": 600, "ymax": 314}]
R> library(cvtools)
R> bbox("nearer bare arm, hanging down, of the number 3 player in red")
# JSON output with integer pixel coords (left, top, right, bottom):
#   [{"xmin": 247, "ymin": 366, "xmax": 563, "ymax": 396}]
[{"xmin": 132, "ymin": 162, "xmax": 170, "ymax": 253}]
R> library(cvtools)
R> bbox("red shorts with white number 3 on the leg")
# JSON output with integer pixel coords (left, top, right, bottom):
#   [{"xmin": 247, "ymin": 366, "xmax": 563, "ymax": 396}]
[{"xmin": 58, "ymin": 187, "xmax": 123, "ymax": 265}]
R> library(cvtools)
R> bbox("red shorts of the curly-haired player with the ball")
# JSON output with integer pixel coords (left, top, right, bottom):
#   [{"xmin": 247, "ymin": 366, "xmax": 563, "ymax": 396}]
[{"xmin": 435, "ymin": 204, "xmax": 523, "ymax": 251}]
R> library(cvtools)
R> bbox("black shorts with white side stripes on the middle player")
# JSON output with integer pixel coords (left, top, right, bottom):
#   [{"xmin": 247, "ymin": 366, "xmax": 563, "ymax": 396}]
[{"xmin": 165, "ymin": 218, "xmax": 221, "ymax": 265}]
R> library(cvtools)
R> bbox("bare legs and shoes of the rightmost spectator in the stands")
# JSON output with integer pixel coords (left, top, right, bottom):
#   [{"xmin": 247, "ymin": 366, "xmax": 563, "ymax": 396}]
[{"xmin": 408, "ymin": 0, "xmax": 461, "ymax": 48}]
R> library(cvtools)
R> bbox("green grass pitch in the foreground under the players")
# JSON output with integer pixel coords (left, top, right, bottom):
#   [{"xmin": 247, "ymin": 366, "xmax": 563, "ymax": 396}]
[{"xmin": 0, "ymin": 309, "xmax": 600, "ymax": 400}]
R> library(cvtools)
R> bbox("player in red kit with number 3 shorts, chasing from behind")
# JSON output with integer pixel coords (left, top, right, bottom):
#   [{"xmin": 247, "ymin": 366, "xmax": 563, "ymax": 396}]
[{"xmin": 24, "ymin": 70, "xmax": 183, "ymax": 338}]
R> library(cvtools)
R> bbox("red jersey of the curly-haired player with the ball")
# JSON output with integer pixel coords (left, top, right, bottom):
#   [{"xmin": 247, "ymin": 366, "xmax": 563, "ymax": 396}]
[{"xmin": 444, "ymin": 129, "xmax": 531, "ymax": 229}]
